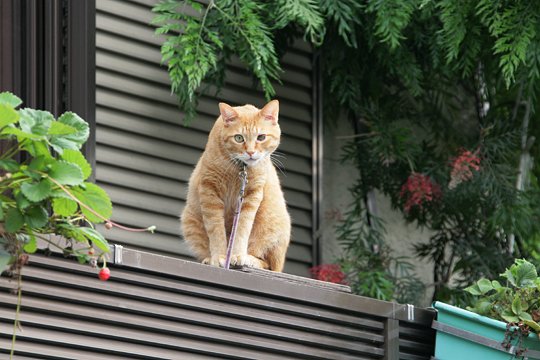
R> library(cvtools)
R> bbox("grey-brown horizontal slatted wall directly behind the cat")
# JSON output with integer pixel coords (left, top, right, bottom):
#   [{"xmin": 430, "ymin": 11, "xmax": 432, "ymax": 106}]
[{"xmin": 96, "ymin": 0, "xmax": 313, "ymax": 275}]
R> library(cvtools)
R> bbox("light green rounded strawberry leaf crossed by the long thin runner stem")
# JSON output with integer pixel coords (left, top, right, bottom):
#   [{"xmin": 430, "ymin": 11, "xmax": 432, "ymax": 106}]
[{"xmin": 73, "ymin": 182, "xmax": 112, "ymax": 223}]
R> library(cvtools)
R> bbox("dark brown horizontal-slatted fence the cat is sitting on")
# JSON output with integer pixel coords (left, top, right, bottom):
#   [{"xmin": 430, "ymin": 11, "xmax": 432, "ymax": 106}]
[{"xmin": 0, "ymin": 247, "xmax": 434, "ymax": 360}]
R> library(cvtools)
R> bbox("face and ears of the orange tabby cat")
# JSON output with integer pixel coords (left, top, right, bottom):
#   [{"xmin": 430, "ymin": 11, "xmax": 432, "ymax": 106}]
[{"xmin": 219, "ymin": 100, "xmax": 281, "ymax": 166}]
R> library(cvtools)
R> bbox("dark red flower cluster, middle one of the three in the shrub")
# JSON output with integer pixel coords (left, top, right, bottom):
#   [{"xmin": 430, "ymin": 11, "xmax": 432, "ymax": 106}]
[{"xmin": 399, "ymin": 173, "xmax": 441, "ymax": 213}]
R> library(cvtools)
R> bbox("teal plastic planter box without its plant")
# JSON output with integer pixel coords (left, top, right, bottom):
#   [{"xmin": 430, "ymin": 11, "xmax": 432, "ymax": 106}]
[{"xmin": 433, "ymin": 302, "xmax": 540, "ymax": 360}]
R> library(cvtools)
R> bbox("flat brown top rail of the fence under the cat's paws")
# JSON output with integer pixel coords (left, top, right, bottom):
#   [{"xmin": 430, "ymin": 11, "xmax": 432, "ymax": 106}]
[{"xmin": 27, "ymin": 245, "xmax": 435, "ymax": 326}]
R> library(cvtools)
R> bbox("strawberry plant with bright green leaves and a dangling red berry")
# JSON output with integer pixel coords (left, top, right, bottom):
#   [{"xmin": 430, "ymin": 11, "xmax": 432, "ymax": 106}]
[{"xmin": 0, "ymin": 92, "xmax": 154, "ymax": 355}]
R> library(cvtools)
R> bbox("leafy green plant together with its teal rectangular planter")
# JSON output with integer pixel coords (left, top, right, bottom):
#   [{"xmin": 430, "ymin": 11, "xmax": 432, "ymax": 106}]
[{"xmin": 433, "ymin": 259, "xmax": 540, "ymax": 360}]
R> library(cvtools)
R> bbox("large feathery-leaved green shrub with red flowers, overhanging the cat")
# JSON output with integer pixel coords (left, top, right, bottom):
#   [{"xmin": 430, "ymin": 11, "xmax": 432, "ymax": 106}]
[{"xmin": 151, "ymin": 0, "xmax": 540, "ymax": 302}]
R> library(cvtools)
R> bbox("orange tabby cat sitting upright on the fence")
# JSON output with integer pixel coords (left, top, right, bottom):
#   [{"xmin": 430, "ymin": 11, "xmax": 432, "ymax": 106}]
[{"xmin": 181, "ymin": 100, "xmax": 291, "ymax": 271}]
